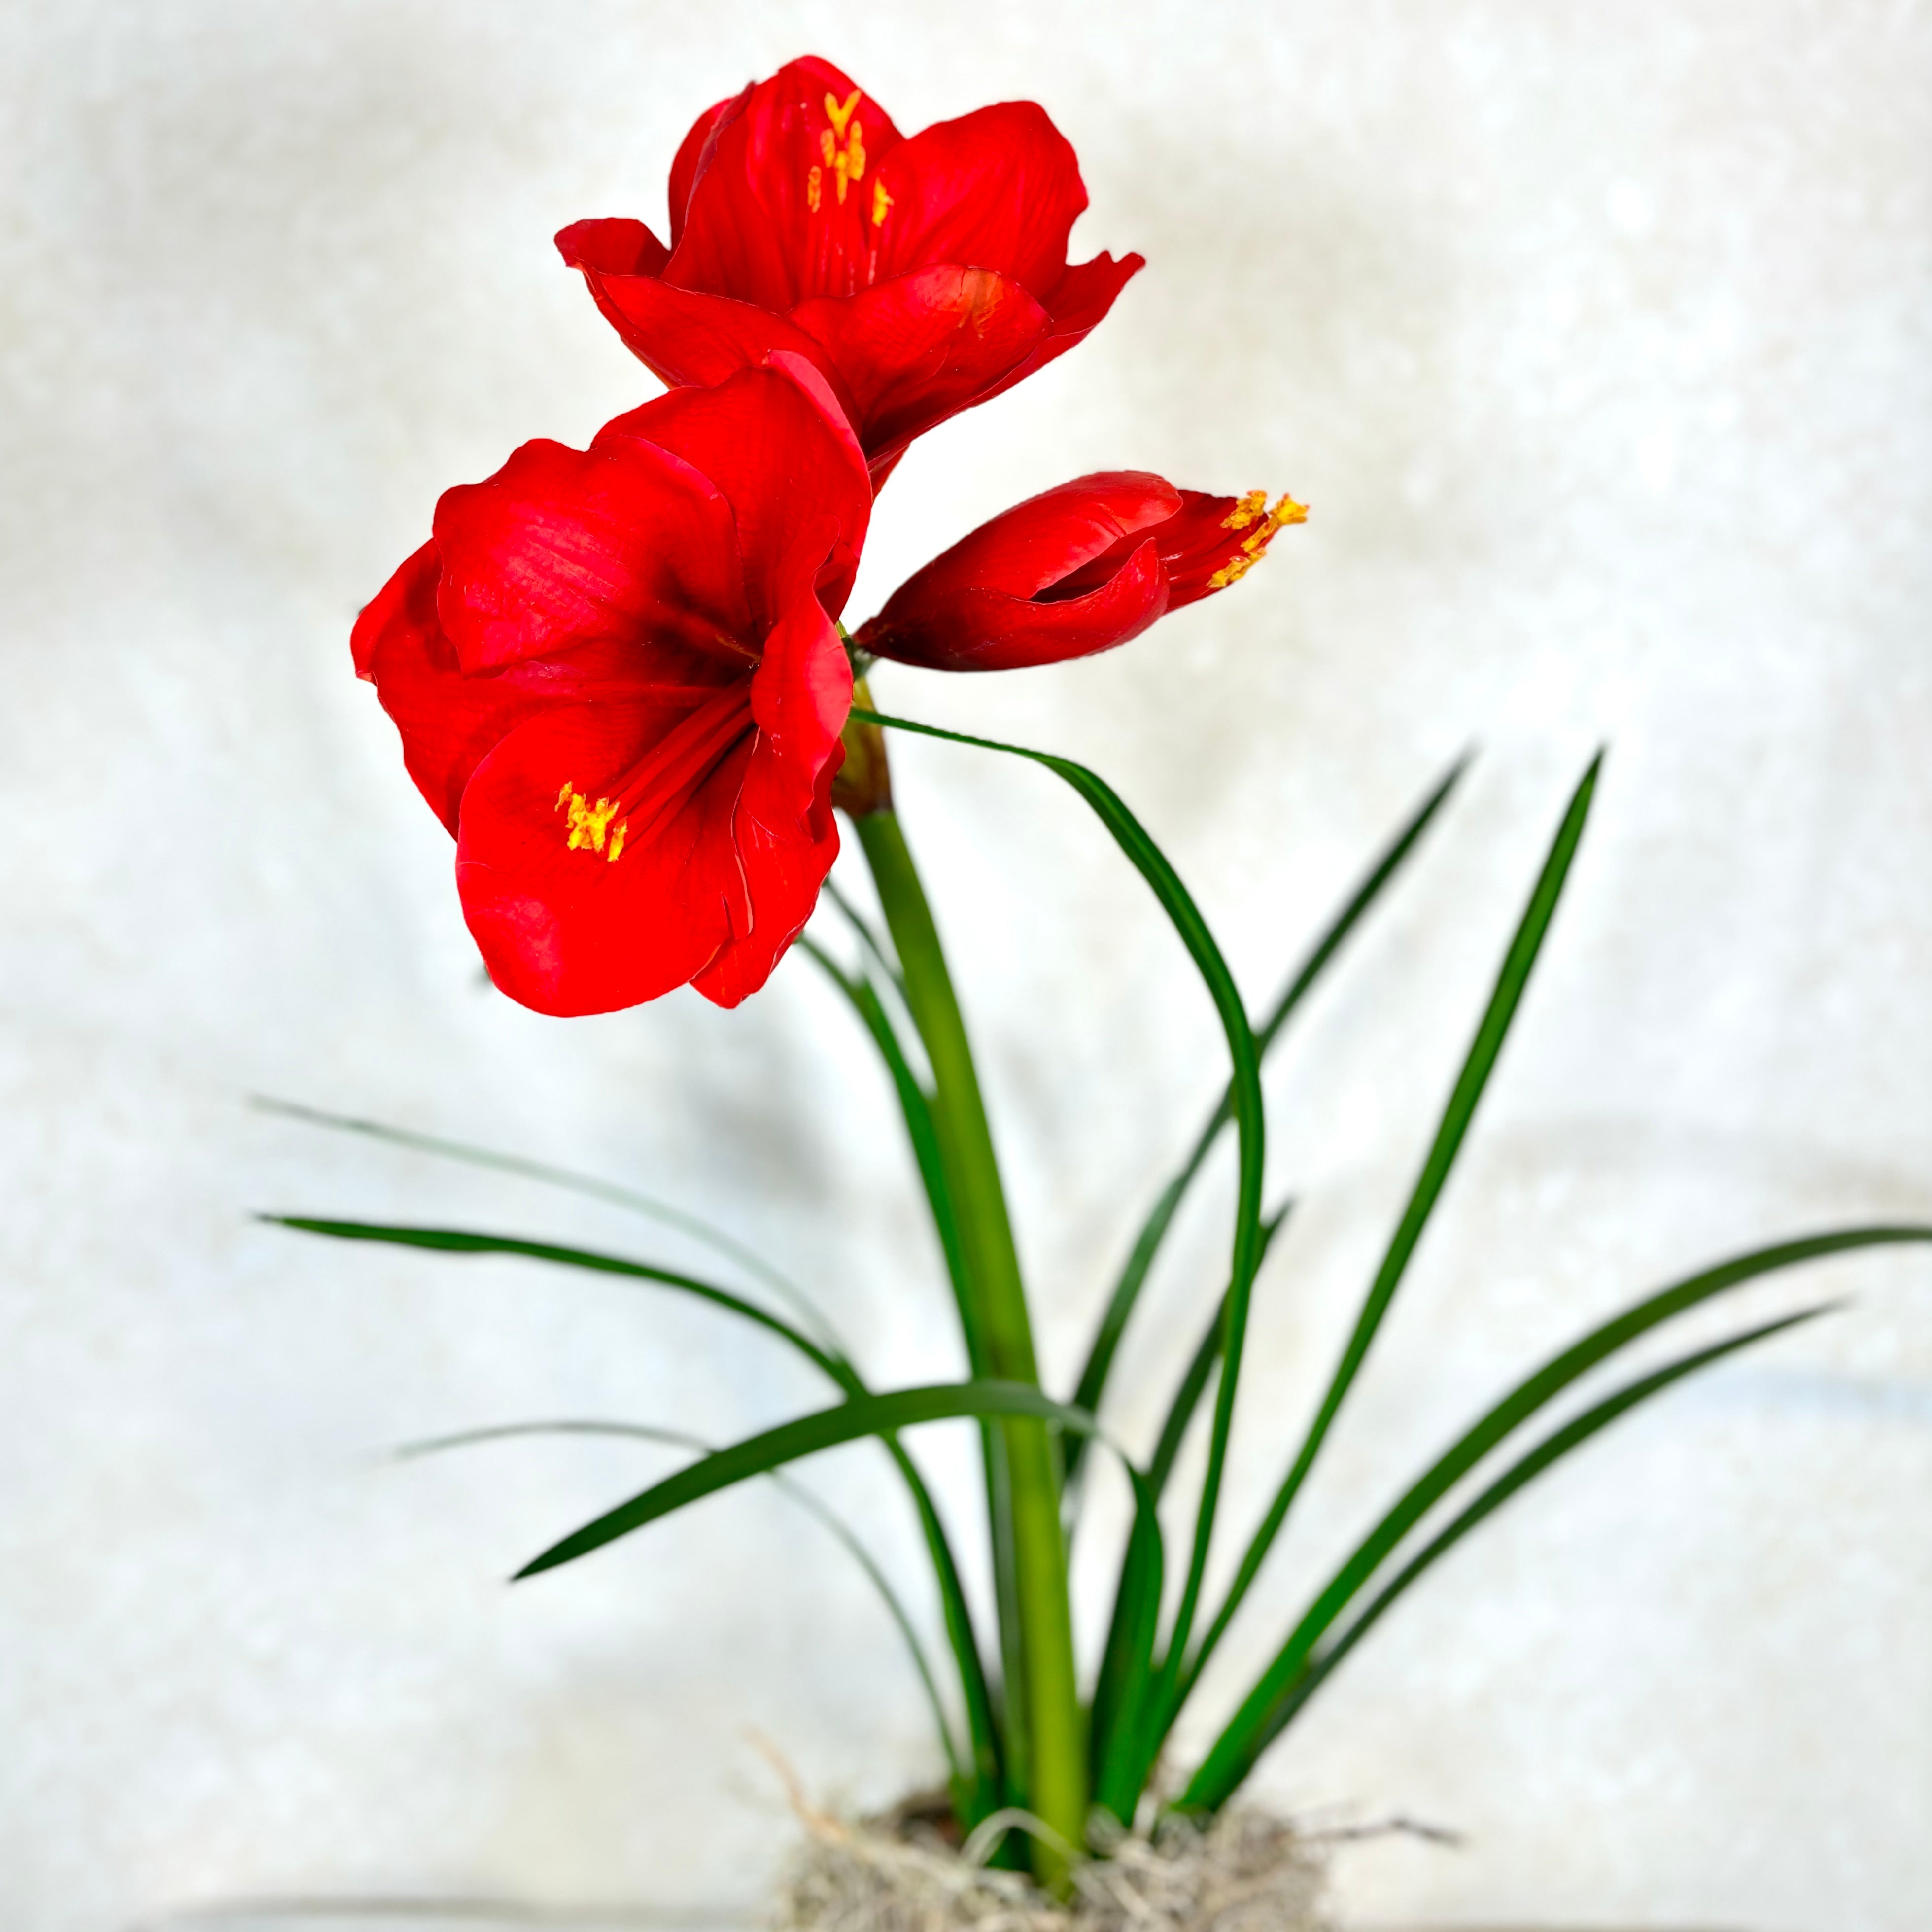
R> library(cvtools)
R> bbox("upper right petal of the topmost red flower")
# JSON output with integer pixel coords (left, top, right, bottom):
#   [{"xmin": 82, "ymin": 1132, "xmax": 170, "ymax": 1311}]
[{"xmin": 877, "ymin": 101, "xmax": 1088, "ymax": 303}]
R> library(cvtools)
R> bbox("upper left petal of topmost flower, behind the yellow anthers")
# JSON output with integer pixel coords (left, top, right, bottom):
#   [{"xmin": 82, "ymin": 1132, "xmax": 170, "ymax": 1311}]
[{"xmin": 666, "ymin": 60, "xmax": 900, "ymax": 311}]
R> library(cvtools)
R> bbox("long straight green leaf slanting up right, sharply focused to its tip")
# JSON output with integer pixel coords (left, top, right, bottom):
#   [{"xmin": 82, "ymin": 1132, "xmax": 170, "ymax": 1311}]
[{"xmin": 1161, "ymin": 752, "xmax": 1604, "ymax": 1735}]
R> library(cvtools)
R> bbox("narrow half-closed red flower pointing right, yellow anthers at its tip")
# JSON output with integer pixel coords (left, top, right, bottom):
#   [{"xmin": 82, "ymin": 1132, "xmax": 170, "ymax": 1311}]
[{"xmin": 852, "ymin": 470, "xmax": 1308, "ymax": 670}]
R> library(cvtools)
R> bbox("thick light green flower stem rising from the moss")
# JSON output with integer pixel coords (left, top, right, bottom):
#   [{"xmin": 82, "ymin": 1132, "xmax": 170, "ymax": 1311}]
[{"xmin": 856, "ymin": 811, "xmax": 1088, "ymax": 1888}]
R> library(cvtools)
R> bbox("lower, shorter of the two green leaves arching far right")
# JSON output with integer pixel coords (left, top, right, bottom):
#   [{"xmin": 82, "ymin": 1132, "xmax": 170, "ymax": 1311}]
[{"xmin": 1176, "ymin": 1302, "xmax": 1837, "ymax": 1810}]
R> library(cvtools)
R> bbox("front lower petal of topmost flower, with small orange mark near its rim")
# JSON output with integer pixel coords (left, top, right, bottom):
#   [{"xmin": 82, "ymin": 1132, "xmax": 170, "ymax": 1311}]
[{"xmin": 792, "ymin": 265, "xmax": 1049, "ymax": 473}]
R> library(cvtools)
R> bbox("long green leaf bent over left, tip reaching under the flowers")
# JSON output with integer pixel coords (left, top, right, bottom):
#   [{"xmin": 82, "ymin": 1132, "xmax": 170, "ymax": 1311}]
[{"xmin": 852, "ymin": 707, "xmax": 1266, "ymax": 1769}]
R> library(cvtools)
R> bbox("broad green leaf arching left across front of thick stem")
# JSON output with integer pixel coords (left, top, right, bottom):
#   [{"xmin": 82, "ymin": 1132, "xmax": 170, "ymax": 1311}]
[{"xmin": 516, "ymin": 1381, "xmax": 1138, "ymax": 1579}]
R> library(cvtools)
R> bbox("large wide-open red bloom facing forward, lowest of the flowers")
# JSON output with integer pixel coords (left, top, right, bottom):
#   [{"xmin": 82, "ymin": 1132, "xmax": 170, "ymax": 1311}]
[{"xmin": 353, "ymin": 353, "xmax": 871, "ymax": 1014}]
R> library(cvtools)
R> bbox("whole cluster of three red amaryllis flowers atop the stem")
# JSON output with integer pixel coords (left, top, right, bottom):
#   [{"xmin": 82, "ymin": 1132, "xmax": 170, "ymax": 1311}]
[{"xmin": 353, "ymin": 60, "xmax": 1306, "ymax": 1014}]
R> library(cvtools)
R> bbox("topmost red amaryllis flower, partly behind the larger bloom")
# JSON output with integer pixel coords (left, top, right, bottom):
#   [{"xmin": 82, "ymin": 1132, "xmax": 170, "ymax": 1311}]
[{"xmin": 556, "ymin": 60, "xmax": 1142, "ymax": 483}]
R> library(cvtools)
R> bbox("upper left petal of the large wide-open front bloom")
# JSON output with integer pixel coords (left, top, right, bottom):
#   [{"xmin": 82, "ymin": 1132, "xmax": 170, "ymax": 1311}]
[{"xmin": 435, "ymin": 435, "xmax": 750, "ymax": 682}]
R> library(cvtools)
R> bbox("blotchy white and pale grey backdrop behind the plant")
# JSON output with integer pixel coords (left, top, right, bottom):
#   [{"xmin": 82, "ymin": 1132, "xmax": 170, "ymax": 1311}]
[{"xmin": 0, "ymin": 0, "xmax": 1932, "ymax": 1932}]
